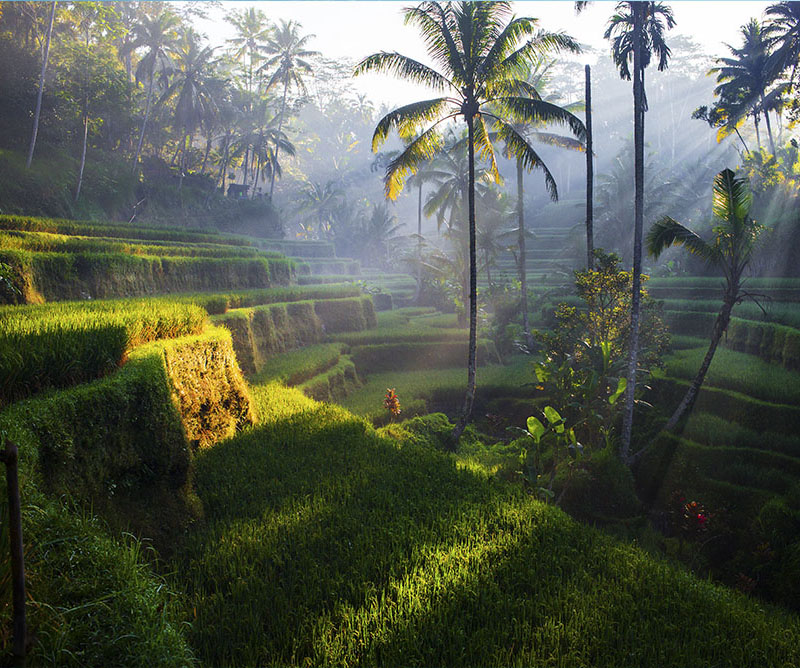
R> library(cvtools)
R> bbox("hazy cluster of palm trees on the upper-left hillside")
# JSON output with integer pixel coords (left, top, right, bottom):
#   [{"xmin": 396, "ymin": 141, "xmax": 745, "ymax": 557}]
[{"xmin": 15, "ymin": 2, "xmax": 317, "ymax": 198}]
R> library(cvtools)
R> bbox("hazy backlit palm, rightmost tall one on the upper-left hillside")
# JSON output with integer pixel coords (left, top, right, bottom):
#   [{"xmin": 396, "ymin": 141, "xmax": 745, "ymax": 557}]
[{"xmin": 262, "ymin": 21, "xmax": 318, "ymax": 199}]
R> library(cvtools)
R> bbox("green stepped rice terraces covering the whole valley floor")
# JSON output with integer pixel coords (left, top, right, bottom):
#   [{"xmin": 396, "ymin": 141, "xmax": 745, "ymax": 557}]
[{"xmin": 0, "ymin": 217, "xmax": 800, "ymax": 666}]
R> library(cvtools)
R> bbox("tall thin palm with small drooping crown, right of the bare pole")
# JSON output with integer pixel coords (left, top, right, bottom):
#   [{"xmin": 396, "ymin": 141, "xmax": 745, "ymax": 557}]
[{"xmin": 605, "ymin": 1, "xmax": 675, "ymax": 461}]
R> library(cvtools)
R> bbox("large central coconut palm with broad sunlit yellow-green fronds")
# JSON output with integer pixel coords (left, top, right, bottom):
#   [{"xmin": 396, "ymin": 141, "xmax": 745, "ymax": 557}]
[{"xmin": 355, "ymin": 2, "xmax": 585, "ymax": 445}]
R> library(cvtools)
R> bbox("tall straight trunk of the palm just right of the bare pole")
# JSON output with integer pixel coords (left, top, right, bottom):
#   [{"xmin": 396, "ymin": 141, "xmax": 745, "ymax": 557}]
[{"xmin": 620, "ymin": 3, "xmax": 646, "ymax": 462}]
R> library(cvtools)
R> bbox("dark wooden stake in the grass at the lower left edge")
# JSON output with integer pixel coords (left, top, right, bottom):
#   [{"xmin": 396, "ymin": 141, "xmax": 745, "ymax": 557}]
[{"xmin": 0, "ymin": 441, "xmax": 28, "ymax": 660}]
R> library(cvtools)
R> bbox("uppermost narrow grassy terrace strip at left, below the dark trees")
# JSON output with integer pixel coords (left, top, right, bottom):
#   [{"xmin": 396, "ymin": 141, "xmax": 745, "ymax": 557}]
[{"xmin": 0, "ymin": 215, "xmax": 253, "ymax": 246}]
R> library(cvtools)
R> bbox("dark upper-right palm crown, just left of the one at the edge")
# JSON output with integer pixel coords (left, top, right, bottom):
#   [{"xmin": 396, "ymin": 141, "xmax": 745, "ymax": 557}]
[{"xmin": 709, "ymin": 19, "xmax": 788, "ymax": 155}]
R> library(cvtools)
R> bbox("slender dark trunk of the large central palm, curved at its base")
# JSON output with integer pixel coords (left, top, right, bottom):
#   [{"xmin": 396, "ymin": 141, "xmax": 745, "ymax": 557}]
[{"xmin": 451, "ymin": 109, "xmax": 478, "ymax": 449}]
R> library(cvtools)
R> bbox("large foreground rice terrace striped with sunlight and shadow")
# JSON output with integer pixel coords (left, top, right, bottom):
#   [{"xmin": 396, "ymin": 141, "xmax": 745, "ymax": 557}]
[{"xmin": 169, "ymin": 385, "xmax": 800, "ymax": 668}]
